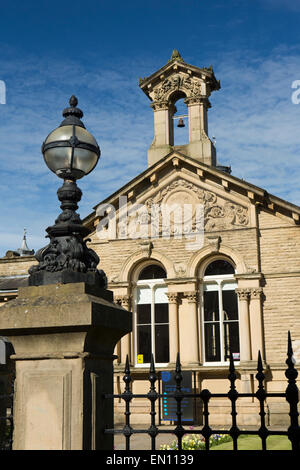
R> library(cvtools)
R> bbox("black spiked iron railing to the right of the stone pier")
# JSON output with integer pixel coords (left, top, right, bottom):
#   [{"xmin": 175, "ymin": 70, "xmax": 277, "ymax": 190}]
[{"xmin": 104, "ymin": 332, "xmax": 300, "ymax": 451}]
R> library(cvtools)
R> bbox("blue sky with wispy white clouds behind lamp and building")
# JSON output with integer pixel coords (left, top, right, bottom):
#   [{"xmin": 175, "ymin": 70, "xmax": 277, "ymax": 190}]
[{"xmin": 0, "ymin": 0, "xmax": 300, "ymax": 257}]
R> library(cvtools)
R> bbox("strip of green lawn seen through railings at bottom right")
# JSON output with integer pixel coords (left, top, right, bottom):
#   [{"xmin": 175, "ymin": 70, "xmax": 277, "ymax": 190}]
[{"xmin": 211, "ymin": 435, "xmax": 292, "ymax": 450}]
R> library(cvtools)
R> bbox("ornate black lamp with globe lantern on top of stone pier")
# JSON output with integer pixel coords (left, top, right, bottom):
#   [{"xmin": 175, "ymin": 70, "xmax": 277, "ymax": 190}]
[{"xmin": 29, "ymin": 96, "xmax": 106, "ymax": 287}]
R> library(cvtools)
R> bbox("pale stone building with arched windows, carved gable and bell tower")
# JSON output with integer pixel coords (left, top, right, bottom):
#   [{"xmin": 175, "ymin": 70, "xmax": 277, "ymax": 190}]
[{"xmin": 0, "ymin": 51, "xmax": 300, "ymax": 425}]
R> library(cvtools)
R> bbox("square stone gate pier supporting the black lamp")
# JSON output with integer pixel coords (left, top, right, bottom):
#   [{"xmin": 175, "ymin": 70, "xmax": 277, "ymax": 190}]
[{"xmin": 0, "ymin": 282, "xmax": 131, "ymax": 450}]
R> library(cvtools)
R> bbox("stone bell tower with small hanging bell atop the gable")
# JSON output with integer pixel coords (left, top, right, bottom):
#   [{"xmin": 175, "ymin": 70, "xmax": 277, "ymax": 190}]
[{"xmin": 139, "ymin": 49, "xmax": 220, "ymax": 166}]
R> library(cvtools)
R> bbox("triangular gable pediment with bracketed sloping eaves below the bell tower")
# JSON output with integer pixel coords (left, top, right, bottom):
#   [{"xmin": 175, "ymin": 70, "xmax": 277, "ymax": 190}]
[{"xmin": 84, "ymin": 151, "xmax": 300, "ymax": 239}]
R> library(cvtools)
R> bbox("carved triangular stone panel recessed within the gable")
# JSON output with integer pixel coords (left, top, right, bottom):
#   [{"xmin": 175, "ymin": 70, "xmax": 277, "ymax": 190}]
[{"xmin": 97, "ymin": 170, "xmax": 251, "ymax": 240}]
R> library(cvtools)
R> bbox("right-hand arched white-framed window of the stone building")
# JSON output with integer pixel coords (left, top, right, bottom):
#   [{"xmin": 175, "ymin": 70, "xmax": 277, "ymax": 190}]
[{"xmin": 202, "ymin": 259, "xmax": 240, "ymax": 364}]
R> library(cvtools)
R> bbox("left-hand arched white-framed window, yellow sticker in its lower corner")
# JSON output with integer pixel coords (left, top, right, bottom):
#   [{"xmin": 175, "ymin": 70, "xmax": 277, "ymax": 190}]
[{"xmin": 134, "ymin": 264, "xmax": 169, "ymax": 366}]
